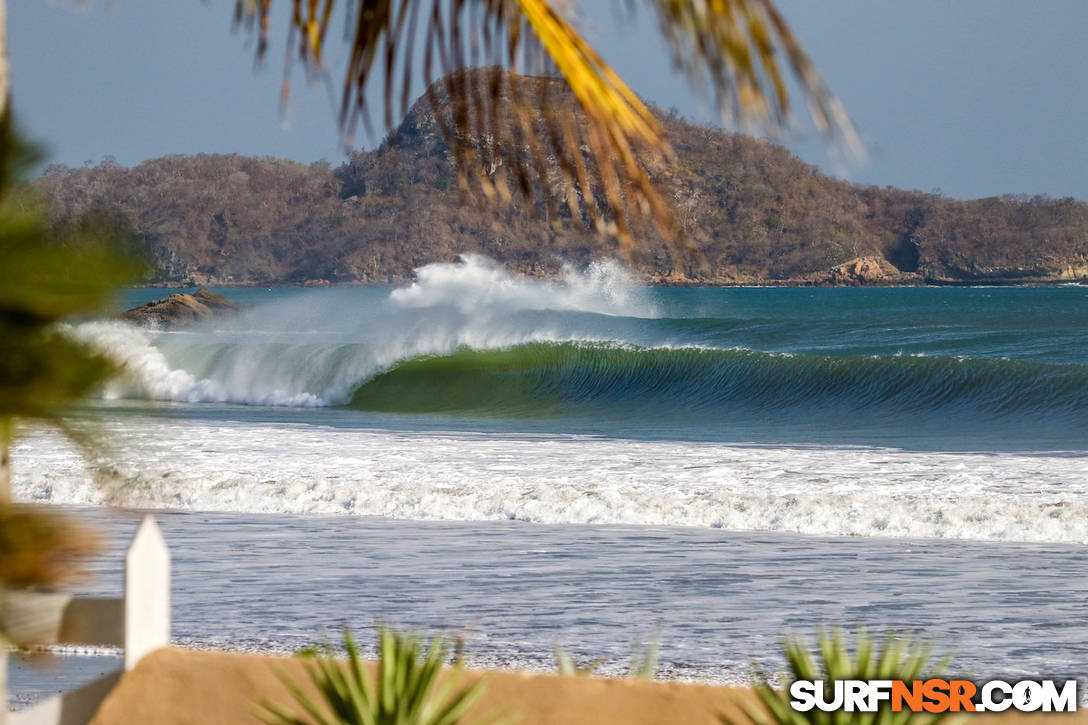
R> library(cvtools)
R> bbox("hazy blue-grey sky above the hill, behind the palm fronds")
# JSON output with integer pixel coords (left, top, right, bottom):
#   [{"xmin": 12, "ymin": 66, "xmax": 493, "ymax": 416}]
[{"xmin": 8, "ymin": 0, "xmax": 1088, "ymax": 199}]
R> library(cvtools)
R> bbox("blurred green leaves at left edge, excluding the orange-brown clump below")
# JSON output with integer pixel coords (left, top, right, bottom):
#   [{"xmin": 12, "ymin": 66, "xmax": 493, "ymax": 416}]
[{"xmin": 0, "ymin": 113, "xmax": 139, "ymax": 505}]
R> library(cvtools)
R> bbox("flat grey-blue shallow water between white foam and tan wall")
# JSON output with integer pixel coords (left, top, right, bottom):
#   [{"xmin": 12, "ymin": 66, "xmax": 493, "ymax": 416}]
[{"xmin": 10, "ymin": 512, "xmax": 1086, "ymax": 686}]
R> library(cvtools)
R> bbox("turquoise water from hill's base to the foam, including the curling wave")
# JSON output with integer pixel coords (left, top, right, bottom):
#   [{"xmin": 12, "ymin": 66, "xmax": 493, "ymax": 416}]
[{"xmin": 116, "ymin": 278, "xmax": 1088, "ymax": 451}]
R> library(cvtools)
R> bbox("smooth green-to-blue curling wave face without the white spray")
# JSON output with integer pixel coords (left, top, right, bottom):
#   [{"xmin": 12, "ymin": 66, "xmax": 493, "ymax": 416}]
[{"xmin": 349, "ymin": 343, "xmax": 1088, "ymax": 426}]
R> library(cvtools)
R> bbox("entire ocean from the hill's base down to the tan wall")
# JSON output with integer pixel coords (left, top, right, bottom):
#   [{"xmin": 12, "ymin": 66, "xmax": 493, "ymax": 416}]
[{"xmin": 13, "ymin": 256, "xmax": 1088, "ymax": 689}]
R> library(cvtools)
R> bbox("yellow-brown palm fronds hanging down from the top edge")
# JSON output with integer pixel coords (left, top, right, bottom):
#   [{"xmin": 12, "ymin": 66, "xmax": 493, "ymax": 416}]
[{"xmin": 235, "ymin": 0, "xmax": 861, "ymax": 253}]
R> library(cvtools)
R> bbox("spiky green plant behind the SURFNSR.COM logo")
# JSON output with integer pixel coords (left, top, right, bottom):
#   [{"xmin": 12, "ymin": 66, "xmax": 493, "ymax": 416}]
[{"xmin": 718, "ymin": 628, "xmax": 950, "ymax": 725}]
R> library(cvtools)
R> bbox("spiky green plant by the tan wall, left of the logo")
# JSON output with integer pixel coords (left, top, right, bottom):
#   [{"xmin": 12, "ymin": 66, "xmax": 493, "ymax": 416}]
[{"xmin": 261, "ymin": 627, "xmax": 497, "ymax": 725}]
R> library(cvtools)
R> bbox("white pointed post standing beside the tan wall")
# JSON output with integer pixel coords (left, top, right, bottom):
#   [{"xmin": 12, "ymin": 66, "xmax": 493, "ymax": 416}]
[{"xmin": 125, "ymin": 516, "xmax": 170, "ymax": 672}]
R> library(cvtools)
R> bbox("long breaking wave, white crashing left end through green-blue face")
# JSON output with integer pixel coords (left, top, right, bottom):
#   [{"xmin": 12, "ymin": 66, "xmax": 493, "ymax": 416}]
[{"xmin": 76, "ymin": 322, "xmax": 1088, "ymax": 427}]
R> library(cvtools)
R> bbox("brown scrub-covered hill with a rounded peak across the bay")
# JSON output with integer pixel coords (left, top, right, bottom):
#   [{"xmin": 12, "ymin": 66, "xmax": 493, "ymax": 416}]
[{"xmin": 39, "ymin": 69, "xmax": 1088, "ymax": 285}]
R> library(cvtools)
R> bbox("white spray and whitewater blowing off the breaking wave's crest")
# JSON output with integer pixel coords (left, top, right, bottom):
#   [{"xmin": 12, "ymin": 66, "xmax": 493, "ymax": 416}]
[{"xmin": 75, "ymin": 255, "xmax": 655, "ymax": 407}]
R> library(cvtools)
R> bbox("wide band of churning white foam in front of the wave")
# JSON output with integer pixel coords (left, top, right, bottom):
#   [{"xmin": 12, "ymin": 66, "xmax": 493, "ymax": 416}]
[{"xmin": 15, "ymin": 419, "xmax": 1088, "ymax": 543}]
